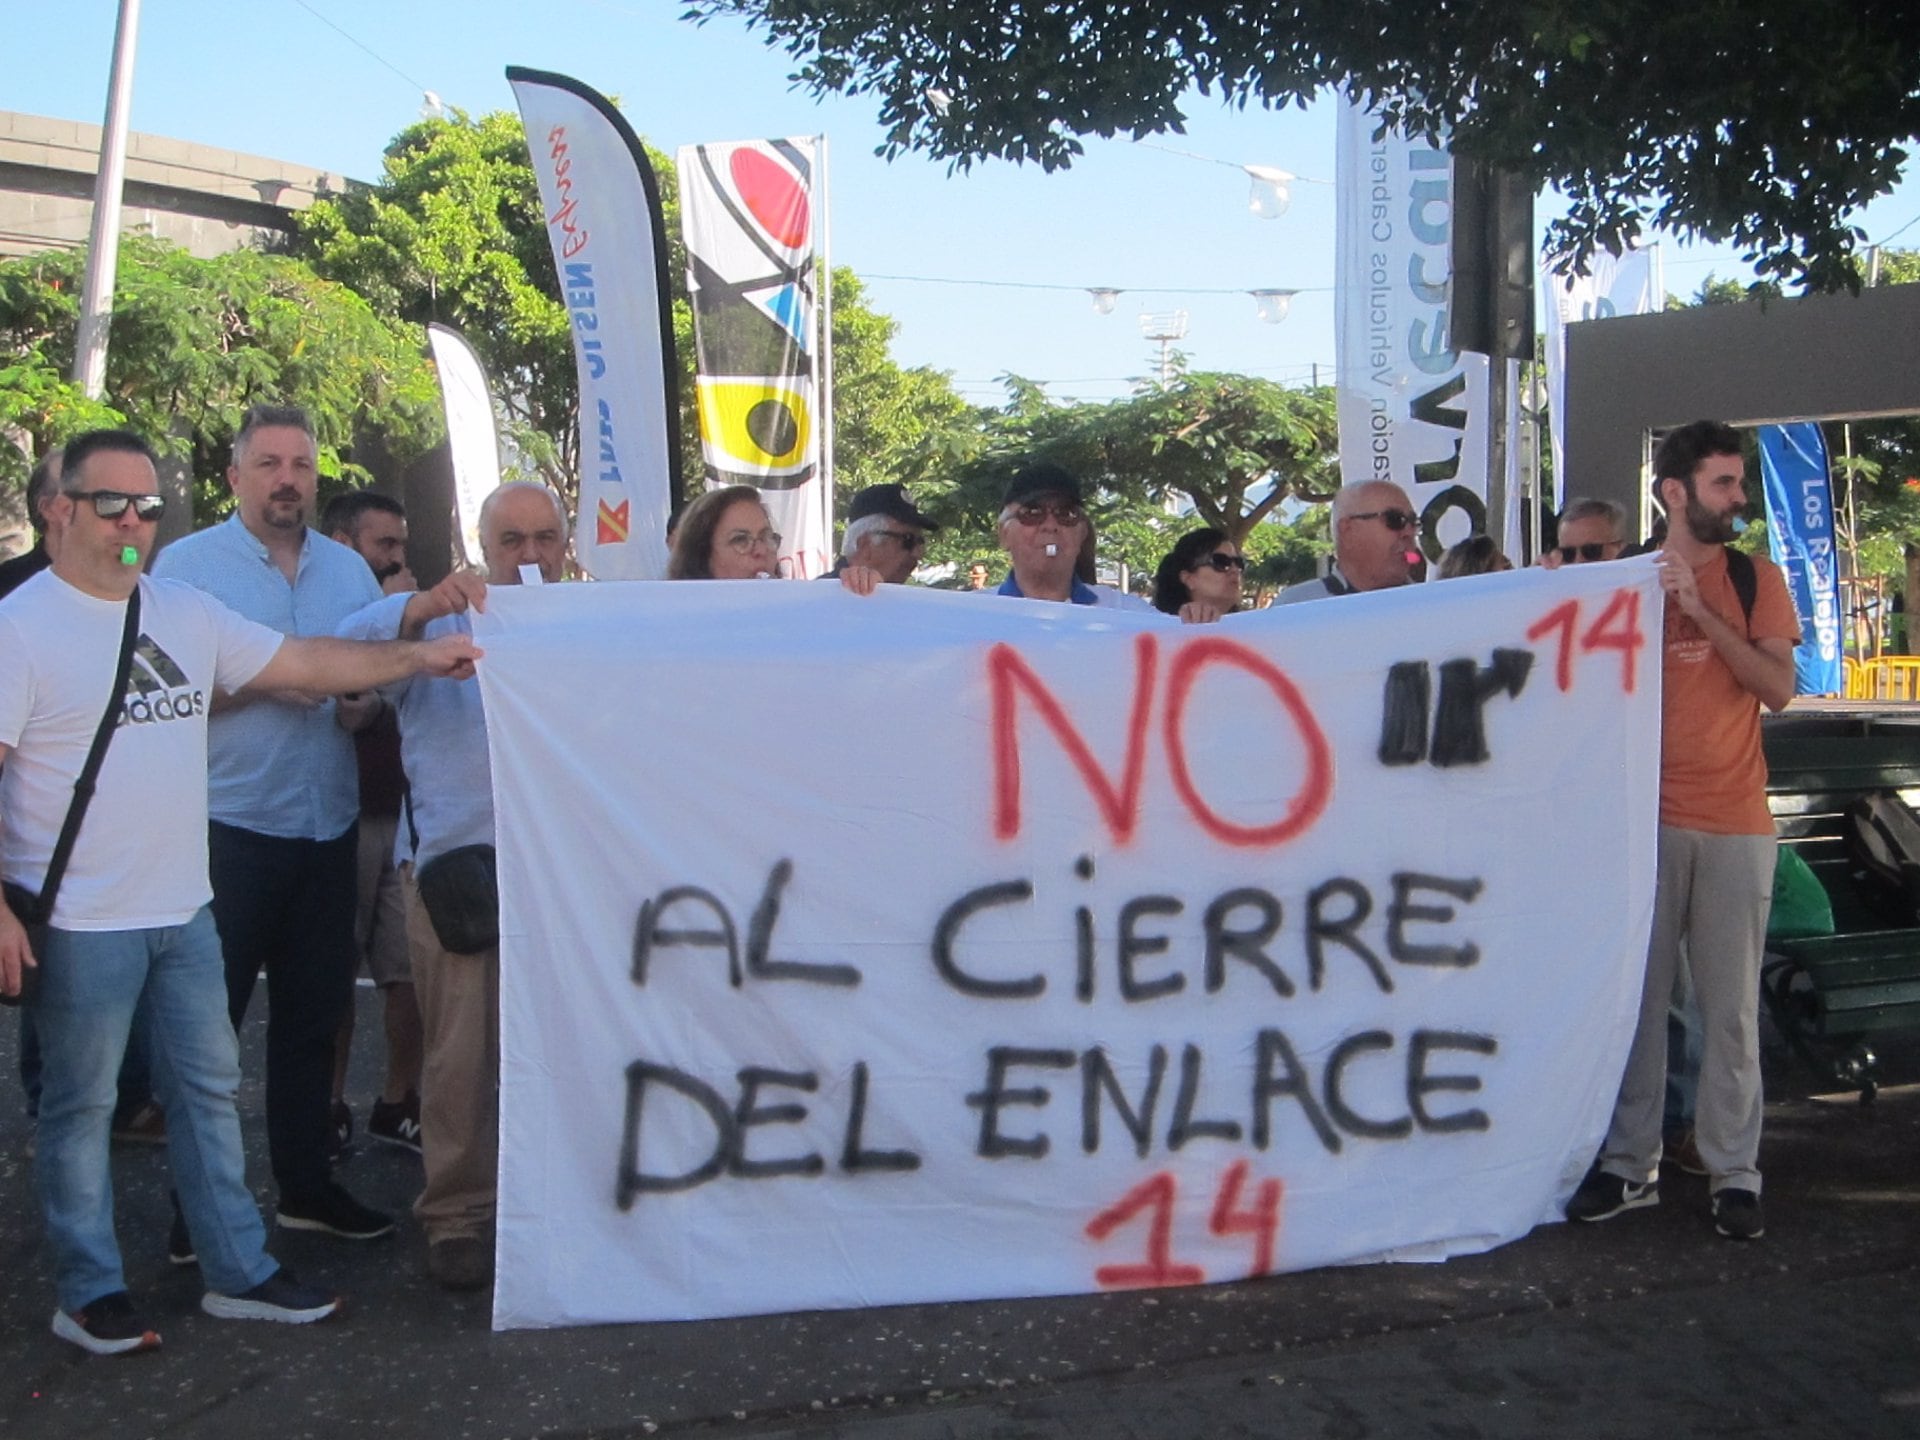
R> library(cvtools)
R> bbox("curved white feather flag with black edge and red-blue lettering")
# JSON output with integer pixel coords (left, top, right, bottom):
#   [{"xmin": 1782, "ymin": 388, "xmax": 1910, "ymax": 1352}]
[{"xmin": 507, "ymin": 65, "xmax": 680, "ymax": 580}]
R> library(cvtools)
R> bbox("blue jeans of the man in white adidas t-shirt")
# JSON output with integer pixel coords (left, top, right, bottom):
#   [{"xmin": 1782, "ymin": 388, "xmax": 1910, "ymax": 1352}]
[{"xmin": 35, "ymin": 906, "xmax": 278, "ymax": 1309}]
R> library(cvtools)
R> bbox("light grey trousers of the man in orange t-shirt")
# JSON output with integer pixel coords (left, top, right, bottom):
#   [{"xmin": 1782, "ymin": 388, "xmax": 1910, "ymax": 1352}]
[{"xmin": 1599, "ymin": 826, "xmax": 1774, "ymax": 1194}]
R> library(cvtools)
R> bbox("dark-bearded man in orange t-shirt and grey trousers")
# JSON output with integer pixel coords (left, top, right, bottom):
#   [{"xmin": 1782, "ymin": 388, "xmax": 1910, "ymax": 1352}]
[{"xmin": 1567, "ymin": 420, "xmax": 1799, "ymax": 1240}]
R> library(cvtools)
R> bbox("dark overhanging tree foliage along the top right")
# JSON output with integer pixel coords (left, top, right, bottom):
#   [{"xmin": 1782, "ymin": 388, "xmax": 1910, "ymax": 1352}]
[{"xmin": 687, "ymin": 0, "xmax": 1920, "ymax": 290}]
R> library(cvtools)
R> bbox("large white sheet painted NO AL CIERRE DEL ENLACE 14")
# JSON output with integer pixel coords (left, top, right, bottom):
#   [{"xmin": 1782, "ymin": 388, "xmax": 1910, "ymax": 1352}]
[{"xmin": 474, "ymin": 561, "xmax": 1659, "ymax": 1329}]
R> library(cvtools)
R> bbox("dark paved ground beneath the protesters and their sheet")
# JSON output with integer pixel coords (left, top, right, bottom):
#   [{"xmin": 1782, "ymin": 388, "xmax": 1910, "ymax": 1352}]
[{"xmin": 0, "ymin": 991, "xmax": 1920, "ymax": 1440}]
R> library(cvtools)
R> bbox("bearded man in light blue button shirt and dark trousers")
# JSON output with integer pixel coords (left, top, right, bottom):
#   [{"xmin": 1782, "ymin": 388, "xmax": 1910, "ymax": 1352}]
[{"xmin": 154, "ymin": 405, "xmax": 394, "ymax": 1240}]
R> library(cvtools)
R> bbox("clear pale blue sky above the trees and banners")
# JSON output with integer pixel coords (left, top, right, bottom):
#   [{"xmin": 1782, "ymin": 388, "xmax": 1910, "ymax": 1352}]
[{"xmin": 15, "ymin": 0, "xmax": 1920, "ymax": 401}]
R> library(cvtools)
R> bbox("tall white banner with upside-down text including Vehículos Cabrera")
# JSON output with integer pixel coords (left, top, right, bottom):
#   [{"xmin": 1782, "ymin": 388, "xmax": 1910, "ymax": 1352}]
[{"xmin": 1334, "ymin": 100, "xmax": 1488, "ymax": 559}]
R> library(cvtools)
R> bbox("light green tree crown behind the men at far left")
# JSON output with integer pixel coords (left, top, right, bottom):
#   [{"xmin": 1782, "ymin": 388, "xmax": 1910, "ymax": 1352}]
[{"xmin": 0, "ymin": 234, "xmax": 442, "ymax": 518}]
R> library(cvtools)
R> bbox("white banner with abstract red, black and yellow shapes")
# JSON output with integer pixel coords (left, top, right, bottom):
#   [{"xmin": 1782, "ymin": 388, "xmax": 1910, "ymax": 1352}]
[{"xmin": 676, "ymin": 136, "xmax": 833, "ymax": 578}]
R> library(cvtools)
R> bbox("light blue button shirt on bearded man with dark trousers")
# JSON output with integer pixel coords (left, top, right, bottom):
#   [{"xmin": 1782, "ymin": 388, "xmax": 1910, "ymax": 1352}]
[{"xmin": 154, "ymin": 515, "xmax": 380, "ymax": 841}]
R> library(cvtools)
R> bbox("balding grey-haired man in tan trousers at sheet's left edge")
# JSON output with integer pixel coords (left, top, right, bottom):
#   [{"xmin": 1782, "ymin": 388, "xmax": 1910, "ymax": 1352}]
[{"xmin": 340, "ymin": 480, "xmax": 566, "ymax": 1290}]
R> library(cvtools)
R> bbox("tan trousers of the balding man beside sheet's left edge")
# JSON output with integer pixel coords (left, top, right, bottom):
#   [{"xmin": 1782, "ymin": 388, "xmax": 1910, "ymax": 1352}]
[{"xmin": 401, "ymin": 864, "xmax": 499, "ymax": 1244}]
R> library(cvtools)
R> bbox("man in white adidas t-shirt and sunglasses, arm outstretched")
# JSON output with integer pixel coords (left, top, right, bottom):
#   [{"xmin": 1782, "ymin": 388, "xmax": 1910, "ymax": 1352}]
[{"xmin": 0, "ymin": 430, "xmax": 478, "ymax": 1354}]
